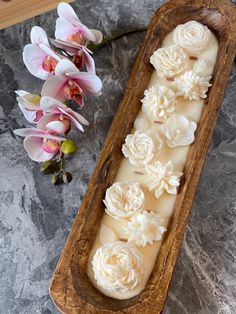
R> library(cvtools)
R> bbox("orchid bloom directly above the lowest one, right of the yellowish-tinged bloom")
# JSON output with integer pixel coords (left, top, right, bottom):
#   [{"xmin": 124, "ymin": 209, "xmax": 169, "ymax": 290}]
[{"xmin": 38, "ymin": 96, "xmax": 89, "ymax": 134}]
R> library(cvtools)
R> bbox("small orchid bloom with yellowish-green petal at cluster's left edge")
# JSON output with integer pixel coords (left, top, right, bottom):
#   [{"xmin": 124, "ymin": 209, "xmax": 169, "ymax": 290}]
[{"xmin": 15, "ymin": 90, "xmax": 44, "ymax": 123}]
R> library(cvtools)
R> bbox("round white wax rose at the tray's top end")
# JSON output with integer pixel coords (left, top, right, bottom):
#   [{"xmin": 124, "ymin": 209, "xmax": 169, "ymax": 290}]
[{"xmin": 173, "ymin": 21, "xmax": 211, "ymax": 55}]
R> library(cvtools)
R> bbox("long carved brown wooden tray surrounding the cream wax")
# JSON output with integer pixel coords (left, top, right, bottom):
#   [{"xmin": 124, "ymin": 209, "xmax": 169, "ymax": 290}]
[{"xmin": 50, "ymin": 0, "xmax": 236, "ymax": 314}]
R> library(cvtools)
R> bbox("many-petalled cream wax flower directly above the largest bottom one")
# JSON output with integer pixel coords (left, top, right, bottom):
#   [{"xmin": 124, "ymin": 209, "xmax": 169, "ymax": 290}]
[{"xmin": 124, "ymin": 211, "xmax": 167, "ymax": 247}]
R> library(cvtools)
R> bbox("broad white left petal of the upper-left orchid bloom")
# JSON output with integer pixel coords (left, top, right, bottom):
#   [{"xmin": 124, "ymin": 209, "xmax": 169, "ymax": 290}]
[{"xmin": 23, "ymin": 44, "xmax": 51, "ymax": 80}]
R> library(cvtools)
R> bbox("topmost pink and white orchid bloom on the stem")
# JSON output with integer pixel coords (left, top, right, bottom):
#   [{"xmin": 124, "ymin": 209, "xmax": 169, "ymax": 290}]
[{"xmin": 55, "ymin": 2, "xmax": 102, "ymax": 45}]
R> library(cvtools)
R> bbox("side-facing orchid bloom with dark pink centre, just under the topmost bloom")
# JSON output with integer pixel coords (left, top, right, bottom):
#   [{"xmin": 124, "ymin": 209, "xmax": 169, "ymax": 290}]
[{"xmin": 50, "ymin": 39, "xmax": 95, "ymax": 73}]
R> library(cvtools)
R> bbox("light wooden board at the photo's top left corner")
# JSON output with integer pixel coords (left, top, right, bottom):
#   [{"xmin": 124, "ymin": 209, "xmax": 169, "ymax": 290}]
[{"xmin": 0, "ymin": 0, "xmax": 72, "ymax": 29}]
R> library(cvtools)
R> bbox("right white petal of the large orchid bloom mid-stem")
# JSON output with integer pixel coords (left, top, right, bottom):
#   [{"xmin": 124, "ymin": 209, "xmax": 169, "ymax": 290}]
[{"xmin": 68, "ymin": 71, "xmax": 102, "ymax": 95}]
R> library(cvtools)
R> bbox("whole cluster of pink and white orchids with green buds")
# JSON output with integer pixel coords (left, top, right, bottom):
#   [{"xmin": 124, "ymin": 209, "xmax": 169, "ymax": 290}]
[{"xmin": 14, "ymin": 2, "xmax": 103, "ymax": 184}]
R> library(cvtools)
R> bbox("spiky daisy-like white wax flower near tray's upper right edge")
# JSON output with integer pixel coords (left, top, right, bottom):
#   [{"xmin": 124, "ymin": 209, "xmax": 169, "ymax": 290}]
[{"xmin": 175, "ymin": 71, "xmax": 211, "ymax": 101}]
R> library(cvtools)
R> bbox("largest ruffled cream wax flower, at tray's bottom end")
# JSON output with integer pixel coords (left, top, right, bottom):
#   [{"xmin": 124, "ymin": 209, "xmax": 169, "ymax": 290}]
[{"xmin": 92, "ymin": 241, "xmax": 145, "ymax": 293}]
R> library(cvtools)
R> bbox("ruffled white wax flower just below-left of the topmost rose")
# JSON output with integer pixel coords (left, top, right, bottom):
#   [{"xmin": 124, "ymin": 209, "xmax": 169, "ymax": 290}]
[{"xmin": 150, "ymin": 45, "xmax": 188, "ymax": 77}]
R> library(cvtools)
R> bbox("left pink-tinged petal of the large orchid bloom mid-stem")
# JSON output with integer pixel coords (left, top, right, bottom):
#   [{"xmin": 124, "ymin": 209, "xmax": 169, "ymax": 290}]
[{"xmin": 41, "ymin": 75, "xmax": 67, "ymax": 101}]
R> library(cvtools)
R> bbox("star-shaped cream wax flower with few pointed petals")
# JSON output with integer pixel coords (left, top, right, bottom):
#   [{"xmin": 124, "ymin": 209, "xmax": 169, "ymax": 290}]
[{"xmin": 145, "ymin": 160, "xmax": 183, "ymax": 198}]
